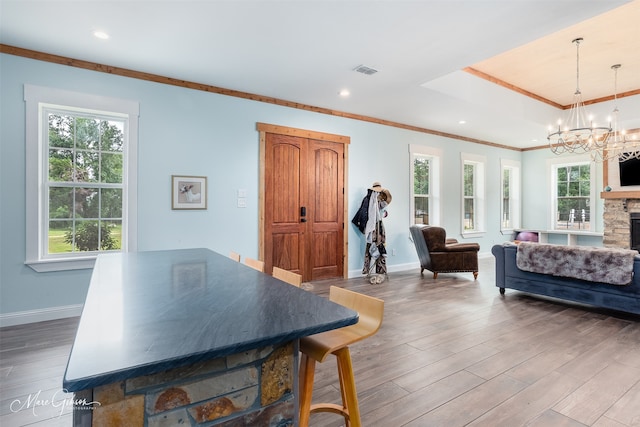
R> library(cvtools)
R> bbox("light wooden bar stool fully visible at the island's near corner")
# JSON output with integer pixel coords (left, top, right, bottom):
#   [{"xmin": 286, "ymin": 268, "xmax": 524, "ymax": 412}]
[{"xmin": 300, "ymin": 286, "xmax": 384, "ymax": 427}]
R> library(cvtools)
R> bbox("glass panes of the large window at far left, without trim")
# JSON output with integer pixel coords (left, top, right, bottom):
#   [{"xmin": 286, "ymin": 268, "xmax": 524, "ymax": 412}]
[{"xmin": 44, "ymin": 109, "xmax": 125, "ymax": 255}]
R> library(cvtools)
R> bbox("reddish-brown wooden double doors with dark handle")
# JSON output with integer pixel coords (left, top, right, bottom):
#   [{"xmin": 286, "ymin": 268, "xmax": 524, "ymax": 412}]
[{"xmin": 261, "ymin": 133, "xmax": 344, "ymax": 281}]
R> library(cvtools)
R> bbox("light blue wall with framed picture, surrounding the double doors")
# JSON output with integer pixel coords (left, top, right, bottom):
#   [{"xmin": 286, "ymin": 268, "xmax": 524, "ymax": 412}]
[{"xmin": 0, "ymin": 54, "xmax": 524, "ymax": 315}]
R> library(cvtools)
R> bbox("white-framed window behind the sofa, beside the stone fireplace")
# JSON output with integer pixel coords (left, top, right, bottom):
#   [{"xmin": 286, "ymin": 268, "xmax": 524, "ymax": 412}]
[{"xmin": 550, "ymin": 158, "xmax": 596, "ymax": 231}]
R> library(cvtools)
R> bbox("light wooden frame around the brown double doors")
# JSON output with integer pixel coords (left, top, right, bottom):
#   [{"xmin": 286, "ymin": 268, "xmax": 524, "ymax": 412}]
[{"xmin": 256, "ymin": 122, "xmax": 351, "ymax": 279}]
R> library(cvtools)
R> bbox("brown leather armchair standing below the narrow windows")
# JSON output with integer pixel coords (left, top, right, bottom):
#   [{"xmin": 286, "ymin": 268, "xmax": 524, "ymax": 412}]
[{"xmin": 409, "ymin": 225, "xmax": 480, "ymax": 280}]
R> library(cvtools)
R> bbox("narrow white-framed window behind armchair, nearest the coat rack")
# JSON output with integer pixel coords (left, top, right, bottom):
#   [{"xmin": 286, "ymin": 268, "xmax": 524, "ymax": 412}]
[{"xmin": 409, "ymin": 144, "xmax": 442, "ymax": 225}]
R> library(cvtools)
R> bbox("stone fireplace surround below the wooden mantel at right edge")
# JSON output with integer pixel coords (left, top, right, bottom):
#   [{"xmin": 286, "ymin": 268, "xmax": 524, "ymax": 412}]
[{"xmin": 603, "ymin": 198, "xmax": 640, "ymax": 249}]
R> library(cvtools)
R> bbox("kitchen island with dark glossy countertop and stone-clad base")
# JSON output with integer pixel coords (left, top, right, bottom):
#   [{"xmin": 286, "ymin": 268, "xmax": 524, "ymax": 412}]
[{"xmin": 63, "ymin": 249, "xmax": 358, "ymax": 427}]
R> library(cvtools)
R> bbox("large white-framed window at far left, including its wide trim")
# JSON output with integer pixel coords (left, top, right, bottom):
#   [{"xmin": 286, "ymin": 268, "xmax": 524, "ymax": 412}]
[{"xmin": 24, "ymin": 85, "xmax": 139, "ymax": 272}]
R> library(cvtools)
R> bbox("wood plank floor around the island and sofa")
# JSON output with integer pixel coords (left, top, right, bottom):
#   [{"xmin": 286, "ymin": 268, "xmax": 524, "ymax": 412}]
[{"xmin": 0, "ymin": 258, "xmax": 640, "ymax": 427}]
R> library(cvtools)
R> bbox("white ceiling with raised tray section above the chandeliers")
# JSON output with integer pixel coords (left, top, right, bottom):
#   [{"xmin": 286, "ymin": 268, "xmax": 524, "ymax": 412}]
[{"xmin": 0, "ymin": 0, "xmax": 640, "ymax": 148}]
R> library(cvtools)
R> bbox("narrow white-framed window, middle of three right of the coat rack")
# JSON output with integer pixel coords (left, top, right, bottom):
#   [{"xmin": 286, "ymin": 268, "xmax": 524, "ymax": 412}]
[{"xmin": 461, "ymin": 153, "xmax": 486, "ymax": 237}]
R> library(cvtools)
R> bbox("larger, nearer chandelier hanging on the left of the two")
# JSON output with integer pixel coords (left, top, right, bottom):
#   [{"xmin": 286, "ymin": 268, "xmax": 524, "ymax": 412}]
[{"xmin": 547, "ymin": 38, "xmax": 612, "ymax": 157}]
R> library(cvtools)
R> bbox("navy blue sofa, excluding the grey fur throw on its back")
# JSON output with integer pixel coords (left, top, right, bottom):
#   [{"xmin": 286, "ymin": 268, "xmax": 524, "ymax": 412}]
[{"xmin": 491, "ymin": 244, "xmax": 640, "ymax": 314}]
